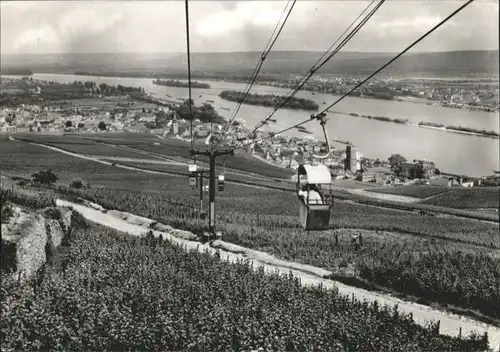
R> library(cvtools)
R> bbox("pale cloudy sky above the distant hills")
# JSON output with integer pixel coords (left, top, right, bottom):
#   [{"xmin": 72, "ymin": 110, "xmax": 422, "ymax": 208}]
[{"xmin": 0, "ymin": 0, "xmax": 499, "ymax": 54}]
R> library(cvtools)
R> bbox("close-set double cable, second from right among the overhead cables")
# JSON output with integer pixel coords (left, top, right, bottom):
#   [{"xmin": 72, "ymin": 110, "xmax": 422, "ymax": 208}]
[{"xmin": 248, "ymin": 0, "xmax": 385, "ymax": 140}]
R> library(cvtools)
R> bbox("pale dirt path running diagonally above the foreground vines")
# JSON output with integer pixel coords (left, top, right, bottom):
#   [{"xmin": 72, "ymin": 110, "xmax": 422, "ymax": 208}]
[{"xmin": 57, "ymin": 199, "xmax": 500, "ymax": 351}]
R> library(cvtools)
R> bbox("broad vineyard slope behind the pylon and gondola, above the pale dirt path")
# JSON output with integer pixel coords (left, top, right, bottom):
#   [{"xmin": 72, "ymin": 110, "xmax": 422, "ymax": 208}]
[{"xmin": 0, "ymin": 136, "xmax": 500, "ymax": 320}]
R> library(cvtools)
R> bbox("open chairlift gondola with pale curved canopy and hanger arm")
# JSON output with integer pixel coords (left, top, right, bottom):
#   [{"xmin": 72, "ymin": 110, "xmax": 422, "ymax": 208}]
[{"xmin": 297, "ymin": 113, "xmax": 333, "ymax": 231}]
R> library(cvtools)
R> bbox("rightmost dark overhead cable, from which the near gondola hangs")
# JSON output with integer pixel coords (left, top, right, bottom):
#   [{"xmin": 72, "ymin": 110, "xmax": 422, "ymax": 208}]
[{"xmin": 234, "ymin": 0, "xmax": 474, "ymax": 149}]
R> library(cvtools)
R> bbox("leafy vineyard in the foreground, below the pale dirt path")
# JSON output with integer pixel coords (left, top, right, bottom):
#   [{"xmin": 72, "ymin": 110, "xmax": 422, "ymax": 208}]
[{"xmin": 0, "ymin": 225, "xmax": 488, "ymax": 351}]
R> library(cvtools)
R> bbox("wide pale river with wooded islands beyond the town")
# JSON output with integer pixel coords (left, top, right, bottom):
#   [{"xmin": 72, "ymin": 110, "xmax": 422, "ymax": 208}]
[{"xmin": 33, "ymin": 73, "xmax": 500, "ymax": 176}]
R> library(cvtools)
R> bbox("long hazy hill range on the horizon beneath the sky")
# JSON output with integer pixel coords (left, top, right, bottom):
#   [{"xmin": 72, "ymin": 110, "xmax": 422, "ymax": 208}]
[{"xmin": 1, "ymin": 50, "xmax": 499, "ymax": 77}]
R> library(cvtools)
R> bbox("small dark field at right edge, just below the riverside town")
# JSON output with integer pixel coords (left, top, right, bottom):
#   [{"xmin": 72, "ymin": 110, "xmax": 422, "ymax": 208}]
[{"xmin": 422, "ymin": 187, "xmax": 500, "ymax": 209}]
